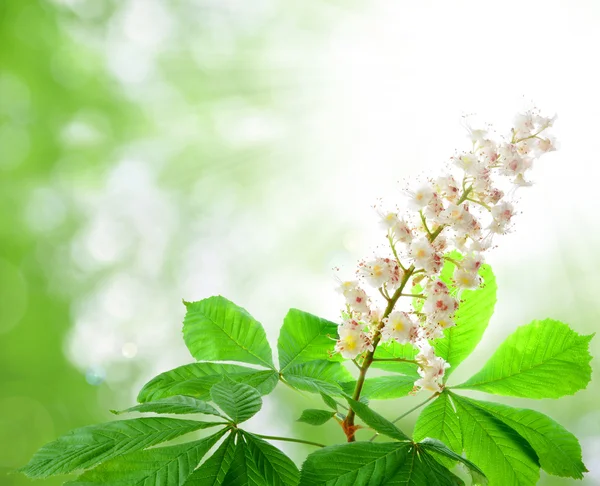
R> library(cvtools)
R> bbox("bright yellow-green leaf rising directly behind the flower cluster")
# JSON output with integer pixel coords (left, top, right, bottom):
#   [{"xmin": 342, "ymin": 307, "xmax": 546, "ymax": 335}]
[{"xmin": 432, "ymin": 261, "xmax": 497, "ymax": 381}]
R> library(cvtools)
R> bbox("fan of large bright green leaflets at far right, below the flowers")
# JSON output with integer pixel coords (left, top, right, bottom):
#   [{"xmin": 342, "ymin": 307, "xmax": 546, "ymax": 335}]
[{"xmin": 414, "ymin": 320, "xmax": 592, "ymax": 485}]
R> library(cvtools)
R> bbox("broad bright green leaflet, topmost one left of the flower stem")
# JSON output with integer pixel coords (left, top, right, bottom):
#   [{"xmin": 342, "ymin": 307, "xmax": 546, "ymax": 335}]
[{"xmin": 183, "ymin": 296, "xmax": 273, "ymax": 368}]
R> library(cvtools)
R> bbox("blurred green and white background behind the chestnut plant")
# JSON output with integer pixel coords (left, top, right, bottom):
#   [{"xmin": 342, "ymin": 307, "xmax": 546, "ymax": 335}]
[{"xmin": 0, "ymin": 0, "xmax": 600, "ymax": 486}]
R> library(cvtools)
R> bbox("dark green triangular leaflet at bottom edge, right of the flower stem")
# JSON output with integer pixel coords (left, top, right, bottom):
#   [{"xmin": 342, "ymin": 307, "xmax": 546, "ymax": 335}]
[{"xmin": 385, "ymin": 444, "xmax": 464, "ymax": 486}]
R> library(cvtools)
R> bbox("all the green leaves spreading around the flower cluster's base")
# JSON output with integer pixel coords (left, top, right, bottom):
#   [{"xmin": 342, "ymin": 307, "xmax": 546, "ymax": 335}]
[{"xmin": 22, "ymin": 292, "xmax": 591, "ymax": 486}]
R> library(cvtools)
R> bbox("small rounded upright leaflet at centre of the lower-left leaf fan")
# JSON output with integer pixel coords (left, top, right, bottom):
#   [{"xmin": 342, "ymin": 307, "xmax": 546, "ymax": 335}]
[{"xmin": 210, "ymin": 378, "xmax": 262, "ymax": 424}]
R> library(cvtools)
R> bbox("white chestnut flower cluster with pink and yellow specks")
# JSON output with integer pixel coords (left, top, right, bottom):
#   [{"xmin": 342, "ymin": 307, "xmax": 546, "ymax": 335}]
[{"xmin": 335, "ymin": 111, "xmax": 555, "ymax": 392}]
